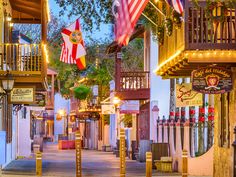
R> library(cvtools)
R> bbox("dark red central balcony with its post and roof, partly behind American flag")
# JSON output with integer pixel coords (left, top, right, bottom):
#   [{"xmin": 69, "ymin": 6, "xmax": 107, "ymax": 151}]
[{"xmin": 107, "ymin": 25, "xmax": 150, "ymax": 100}]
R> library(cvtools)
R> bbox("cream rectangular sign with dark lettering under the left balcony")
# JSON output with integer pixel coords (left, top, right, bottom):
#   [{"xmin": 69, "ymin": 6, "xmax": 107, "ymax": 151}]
[{"xmin": 10, "ymin": 87, "xmax": 35, "ymax": 104}]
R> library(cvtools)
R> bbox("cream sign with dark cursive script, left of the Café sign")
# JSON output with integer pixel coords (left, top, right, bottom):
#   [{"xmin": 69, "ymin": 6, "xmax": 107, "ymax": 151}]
[{"xmin": 176, "ymin": 83, "xmax": 203, "ymax": 107}]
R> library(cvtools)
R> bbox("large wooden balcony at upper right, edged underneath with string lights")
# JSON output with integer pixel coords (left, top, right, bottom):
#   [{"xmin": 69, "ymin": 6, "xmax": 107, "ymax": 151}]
[{"xmin": 156, "ymin": 0, "xmax": 236, "ymax": 78}]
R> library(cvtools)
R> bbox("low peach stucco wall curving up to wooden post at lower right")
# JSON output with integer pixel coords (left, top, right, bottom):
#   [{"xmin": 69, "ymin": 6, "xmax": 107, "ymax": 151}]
[{"xmin": 188, "ymin": 147, "xmax": 213, "ymax": 176}]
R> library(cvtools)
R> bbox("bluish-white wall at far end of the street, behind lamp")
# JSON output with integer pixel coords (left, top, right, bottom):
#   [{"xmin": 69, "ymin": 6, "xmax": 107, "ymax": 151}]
[{"xmin": 54, "ymin": 93, "xmax": 70, "ymax": 141}]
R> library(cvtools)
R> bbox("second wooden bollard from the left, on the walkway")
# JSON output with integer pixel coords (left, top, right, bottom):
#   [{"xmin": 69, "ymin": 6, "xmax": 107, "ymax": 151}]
[{"xmin": 75, "ymin": 131, "xmax": 82, "ymax": 177}]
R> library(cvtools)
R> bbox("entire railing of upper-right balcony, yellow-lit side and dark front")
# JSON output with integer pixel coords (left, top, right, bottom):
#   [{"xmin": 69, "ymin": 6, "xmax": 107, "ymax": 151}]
[{"xmin": 159, "ymin": 0, "xmax": 236, "ymax": 63}]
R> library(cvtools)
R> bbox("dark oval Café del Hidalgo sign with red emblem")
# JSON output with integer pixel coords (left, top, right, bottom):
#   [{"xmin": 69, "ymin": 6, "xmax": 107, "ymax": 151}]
[{"xmin": 192, "ymin": 67, "xmax": 233, "ymax": 94}]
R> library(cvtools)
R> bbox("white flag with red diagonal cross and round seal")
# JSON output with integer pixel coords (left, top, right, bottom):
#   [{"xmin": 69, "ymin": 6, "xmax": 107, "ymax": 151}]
[{"xmin": 60, "ymin": 19, "xmax": 86, "ymax": 70}]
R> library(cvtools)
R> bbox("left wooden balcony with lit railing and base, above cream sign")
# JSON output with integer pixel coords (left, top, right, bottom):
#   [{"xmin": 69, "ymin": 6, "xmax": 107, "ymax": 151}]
[{"xmin": 0, "ymin": 43, "xmax": 47, "ymax": 91}]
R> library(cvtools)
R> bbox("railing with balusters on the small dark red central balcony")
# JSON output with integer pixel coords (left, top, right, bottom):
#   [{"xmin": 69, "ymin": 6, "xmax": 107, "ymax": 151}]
[{"xmin": 120, "ymin": 71, "xmax": 150, "ymax": 91}]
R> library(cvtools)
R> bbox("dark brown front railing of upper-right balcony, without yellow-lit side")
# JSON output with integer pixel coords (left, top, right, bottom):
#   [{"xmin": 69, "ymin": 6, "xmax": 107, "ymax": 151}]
[{"xmin": 185, "ymin": 0, "xmax": 236, "ymax": 50}]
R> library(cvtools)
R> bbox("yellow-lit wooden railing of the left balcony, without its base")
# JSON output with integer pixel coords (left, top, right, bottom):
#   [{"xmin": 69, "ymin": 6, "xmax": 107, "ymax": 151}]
[{"xmin": 0, "ymin": 44, "xmax": 43, "ymax": 74}]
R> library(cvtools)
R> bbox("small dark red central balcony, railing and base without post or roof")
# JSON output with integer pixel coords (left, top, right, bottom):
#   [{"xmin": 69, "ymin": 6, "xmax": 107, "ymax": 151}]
[{"xmin": 116, "ymin": 71, "xmax": 150, "ymax": 100}]
